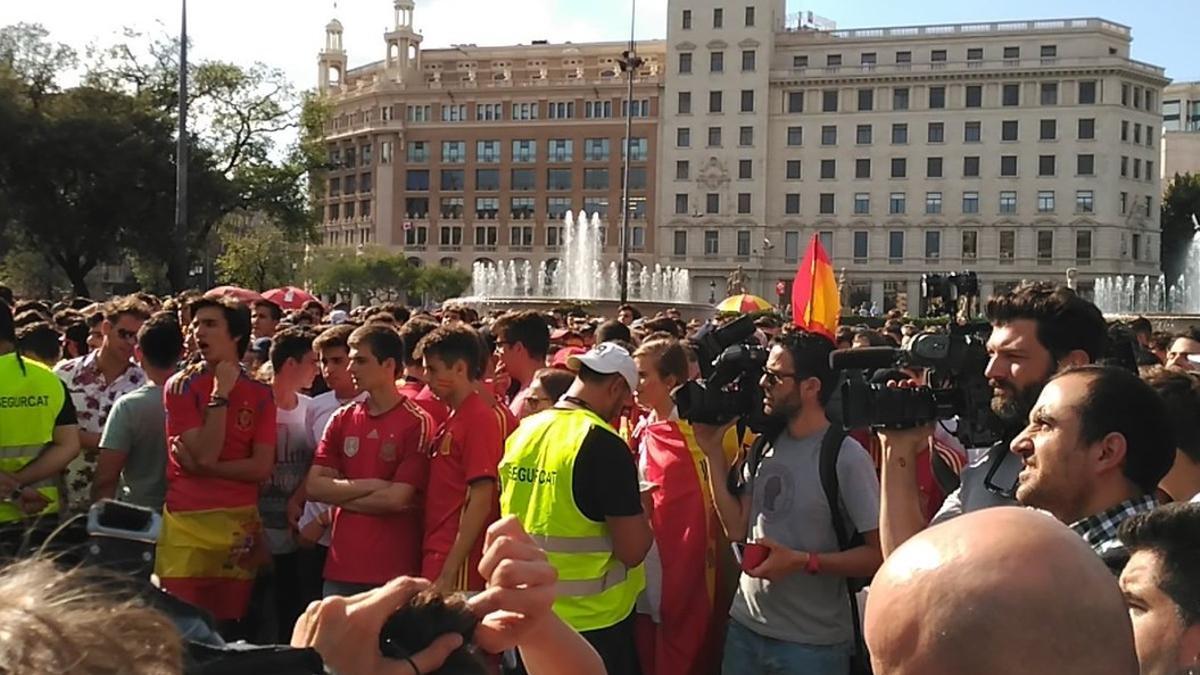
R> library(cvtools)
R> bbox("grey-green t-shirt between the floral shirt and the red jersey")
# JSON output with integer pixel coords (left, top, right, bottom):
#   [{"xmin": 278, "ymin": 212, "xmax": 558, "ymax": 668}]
[{"xmin": 100, "ymin": 382, "xmax": 167, "ymax": 510}]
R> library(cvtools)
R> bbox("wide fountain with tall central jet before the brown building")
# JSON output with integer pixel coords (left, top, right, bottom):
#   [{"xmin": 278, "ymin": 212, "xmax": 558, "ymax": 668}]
[{"xmin": 454, "ymin": 211, "xmax": 712, "ymax": 313}]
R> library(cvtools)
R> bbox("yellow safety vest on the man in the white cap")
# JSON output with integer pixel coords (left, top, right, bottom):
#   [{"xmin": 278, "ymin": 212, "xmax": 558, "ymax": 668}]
[{"xmin": 500, "ymin": 408, "xmax": 646, "ymax": 631}]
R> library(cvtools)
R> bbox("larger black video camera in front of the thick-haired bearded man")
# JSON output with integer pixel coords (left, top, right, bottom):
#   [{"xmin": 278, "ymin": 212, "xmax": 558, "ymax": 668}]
[{"xmin": 829, "ymin": 327, "xmax": 1000, "ymax": 447}]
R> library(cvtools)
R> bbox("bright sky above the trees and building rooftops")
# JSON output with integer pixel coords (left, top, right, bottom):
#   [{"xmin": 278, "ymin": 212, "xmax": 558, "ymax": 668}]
[{"xmin": 0, "ymin": 0, "xmax": 1200, "ymax": 97}]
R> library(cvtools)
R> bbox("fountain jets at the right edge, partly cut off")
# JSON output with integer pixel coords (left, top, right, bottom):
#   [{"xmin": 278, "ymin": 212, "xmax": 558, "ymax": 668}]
[{"xmin": 1094, "ymin": 232, "xmax": 1200, "ymax": 316}]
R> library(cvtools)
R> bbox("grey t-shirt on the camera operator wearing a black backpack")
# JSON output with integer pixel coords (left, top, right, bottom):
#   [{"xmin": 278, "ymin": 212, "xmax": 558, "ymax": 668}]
[{"xmin": 730, "ymin": 430, "xmax": 880, "ymax": 645}]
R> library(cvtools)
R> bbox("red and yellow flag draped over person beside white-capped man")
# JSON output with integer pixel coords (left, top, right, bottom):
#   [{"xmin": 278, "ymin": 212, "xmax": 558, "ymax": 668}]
[{"xmin": 638, "ymin": 420, "xmax": 719, "ymax": 675}]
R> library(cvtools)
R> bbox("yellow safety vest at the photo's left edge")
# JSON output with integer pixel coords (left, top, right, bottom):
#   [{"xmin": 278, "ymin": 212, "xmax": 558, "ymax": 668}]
[{"xmin": 0, "ymin": 352, "xmax": 66, "ymax": 522}]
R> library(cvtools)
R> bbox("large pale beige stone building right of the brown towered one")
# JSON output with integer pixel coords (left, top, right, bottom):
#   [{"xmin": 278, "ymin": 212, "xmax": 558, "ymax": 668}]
[{"xmin": 656, "ymin": 0, "xmax": 1166, "ymax": 310}]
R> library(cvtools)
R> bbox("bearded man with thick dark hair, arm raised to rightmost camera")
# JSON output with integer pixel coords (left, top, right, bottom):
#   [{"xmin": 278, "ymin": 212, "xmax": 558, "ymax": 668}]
[{"xmin": 880, "ymin": 282, "xmax": 1108, "ymax": 556}]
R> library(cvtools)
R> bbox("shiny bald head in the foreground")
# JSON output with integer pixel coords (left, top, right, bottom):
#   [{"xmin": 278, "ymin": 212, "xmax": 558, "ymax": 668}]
[{"xmin": 866, "ymin": 507, "xmax": 1138, "ymax": 675}]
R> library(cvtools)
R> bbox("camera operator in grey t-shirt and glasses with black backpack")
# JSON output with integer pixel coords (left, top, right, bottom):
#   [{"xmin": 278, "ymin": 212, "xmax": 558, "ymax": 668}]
[{"xmin": 694, "ymin": 331, "xmax": 881, "ymax": 675}]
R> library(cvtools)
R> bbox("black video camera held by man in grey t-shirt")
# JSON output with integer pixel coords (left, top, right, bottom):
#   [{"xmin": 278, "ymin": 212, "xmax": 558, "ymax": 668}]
[{"xmin": 671, "ymin": 315, "xmax": 767, "ymax": 431}]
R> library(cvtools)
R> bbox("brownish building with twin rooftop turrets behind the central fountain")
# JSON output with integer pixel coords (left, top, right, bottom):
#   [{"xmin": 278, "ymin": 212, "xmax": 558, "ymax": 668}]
[{"xmin": 318, "ymin": 0, "xmax": 664, "ymax": 278}]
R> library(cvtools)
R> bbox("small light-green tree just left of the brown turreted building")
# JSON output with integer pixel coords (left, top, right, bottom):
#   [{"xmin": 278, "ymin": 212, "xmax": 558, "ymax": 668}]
[{"xmin": 217, "ymin": 216, "xmax": 299, "ymax": 291}]
